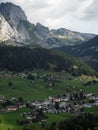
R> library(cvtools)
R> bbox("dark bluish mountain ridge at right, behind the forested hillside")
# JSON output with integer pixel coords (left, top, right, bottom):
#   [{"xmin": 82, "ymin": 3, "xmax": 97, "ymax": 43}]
[{"xmin": 57, "ymin": 35, "xmax": 98, "ymax": 71}]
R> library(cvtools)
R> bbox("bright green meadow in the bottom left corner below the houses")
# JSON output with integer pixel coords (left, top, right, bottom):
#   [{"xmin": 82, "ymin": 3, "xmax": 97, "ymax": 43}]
[{"xmin": 0, "ymin": 108, "xmax": 34, "ymax": 130}]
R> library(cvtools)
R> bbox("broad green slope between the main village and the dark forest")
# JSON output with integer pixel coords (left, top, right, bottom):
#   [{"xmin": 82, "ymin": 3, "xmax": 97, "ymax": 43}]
[{"xmin": 0, "ymin": 71, "xmax": 98, "ymax": 100}]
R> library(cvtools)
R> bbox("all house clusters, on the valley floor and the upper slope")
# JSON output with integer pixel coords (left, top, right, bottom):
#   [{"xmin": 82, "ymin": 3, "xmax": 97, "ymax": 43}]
[{"xmin": 0, "ymin": 73, "xmax": 98, "ymax": 124}]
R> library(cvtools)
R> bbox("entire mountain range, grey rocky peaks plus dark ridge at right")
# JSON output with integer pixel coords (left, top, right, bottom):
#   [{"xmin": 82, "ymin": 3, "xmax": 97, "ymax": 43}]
[{"xmin": 0, "ymin": 2, "xmax": 98, "ymax": 70}]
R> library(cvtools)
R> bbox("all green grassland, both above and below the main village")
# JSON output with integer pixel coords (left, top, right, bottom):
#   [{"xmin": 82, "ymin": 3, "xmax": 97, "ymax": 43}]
[{"xmin": 0, "ymin": 71, "xmax": 98, "ymax": 130}]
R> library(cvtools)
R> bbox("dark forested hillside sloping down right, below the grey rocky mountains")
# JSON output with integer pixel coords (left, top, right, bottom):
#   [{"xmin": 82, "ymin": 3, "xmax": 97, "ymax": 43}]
[{"xmin": 0, "ymin": 46, "xmax": 94, "ymax": 76}]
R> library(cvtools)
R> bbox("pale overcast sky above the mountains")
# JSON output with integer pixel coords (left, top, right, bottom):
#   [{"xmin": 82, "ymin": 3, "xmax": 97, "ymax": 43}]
[{"xmin": 0, "ymin": 0, "xmax": 98, "ymax": 34}]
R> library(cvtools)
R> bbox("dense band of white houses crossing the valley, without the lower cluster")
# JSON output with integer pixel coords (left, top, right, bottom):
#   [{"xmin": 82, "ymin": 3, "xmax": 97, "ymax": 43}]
[{"xmin": 0, "ymin": 93, "xmax": 98, "ymax": 114}]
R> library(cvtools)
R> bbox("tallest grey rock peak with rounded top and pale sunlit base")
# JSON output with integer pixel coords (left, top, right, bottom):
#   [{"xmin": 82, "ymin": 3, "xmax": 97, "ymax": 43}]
[{"xmin": 0, "ymin": 3, "xmax": 29, "ymax": 42}]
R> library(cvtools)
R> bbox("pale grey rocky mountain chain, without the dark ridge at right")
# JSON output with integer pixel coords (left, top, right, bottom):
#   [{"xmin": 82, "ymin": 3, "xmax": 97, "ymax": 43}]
[{"xmin": 0, "ymin": 2, "xmax": 95, "ymax": 48}]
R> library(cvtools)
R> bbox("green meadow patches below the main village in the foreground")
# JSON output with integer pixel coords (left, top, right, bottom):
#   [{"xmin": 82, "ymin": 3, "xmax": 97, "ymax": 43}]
[{"xmin": 0, "ymin": 109, "xmax": 72, "ymax": 130}]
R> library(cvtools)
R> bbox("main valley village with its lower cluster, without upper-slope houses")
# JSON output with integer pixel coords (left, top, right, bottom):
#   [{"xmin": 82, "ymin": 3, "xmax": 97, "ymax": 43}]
[{"xmin": 0, "ymin": 92, "xmax": 98, "ymax": 125}]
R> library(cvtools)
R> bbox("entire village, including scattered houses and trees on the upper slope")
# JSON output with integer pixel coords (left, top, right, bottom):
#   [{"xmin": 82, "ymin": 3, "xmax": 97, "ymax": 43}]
[{"xmin": 0, "ymin": 73, "xmax": 98, "ymax": 125}]
